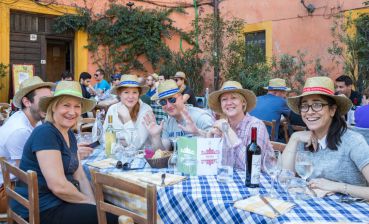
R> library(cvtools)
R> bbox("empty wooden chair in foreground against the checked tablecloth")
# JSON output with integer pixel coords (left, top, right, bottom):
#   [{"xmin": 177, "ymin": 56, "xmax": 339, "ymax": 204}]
[{"xmin": 91, "ymin": 170, "xmax": 157, "ymax": 224}]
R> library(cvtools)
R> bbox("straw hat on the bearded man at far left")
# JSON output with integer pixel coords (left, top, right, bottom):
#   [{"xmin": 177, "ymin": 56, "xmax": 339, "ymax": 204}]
[{"xmin": 13, "ymin": 76, "xmax": 56, "ymax": 108}]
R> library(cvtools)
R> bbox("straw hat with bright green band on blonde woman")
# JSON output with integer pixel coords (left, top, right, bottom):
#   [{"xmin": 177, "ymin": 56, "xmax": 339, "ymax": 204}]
[{"xmin": 38, "ymin": 81, "xmax": 96, "ymax": 114}]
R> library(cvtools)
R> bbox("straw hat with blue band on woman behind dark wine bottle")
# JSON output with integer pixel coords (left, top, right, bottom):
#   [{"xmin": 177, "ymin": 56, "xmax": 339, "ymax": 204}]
[{"xmin": 209, "ymin": 81, "xmax": 256, "ymax": 113}]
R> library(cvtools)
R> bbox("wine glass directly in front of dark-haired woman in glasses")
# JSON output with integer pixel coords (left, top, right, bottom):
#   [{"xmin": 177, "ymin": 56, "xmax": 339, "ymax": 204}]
[{"xmin": 295, "ymin": 151, "xmax": 313, "ymax": 199}]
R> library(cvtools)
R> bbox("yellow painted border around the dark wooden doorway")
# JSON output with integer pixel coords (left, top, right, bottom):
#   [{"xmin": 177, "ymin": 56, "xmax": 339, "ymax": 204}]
[{"xmin": 0, "ymin": 0, "xmax": 88, "ymax": 102}]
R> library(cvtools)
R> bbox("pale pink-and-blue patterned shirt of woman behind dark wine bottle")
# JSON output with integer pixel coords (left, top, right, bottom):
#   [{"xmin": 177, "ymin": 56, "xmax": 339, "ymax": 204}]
[{"xmin": 226, "ymin": 113, "xmax": 274, "ymax": 170}]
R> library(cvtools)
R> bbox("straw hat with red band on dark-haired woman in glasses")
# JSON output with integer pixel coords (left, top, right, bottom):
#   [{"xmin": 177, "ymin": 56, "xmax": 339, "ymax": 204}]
[{"xmin": 287, "ymin": 76, "xmax": 352, "ymax": 115}]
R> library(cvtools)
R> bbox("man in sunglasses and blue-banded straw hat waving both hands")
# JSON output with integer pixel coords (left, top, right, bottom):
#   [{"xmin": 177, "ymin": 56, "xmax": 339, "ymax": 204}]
[{"xmin": 145, "ymin": 80, "xmax": 214, "ymax": 150}]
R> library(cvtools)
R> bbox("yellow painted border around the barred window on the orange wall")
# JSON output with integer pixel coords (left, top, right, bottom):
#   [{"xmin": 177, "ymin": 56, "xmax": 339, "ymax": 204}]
[{"xmin": 242, "ymin": 21, "xmax": 273, "ymax": 61}]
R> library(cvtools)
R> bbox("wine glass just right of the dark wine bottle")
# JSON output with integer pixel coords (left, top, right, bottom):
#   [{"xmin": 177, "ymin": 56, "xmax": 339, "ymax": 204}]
[{"xmin": 263, "ymin": 150, "xmax": 281, "ymax": 198}]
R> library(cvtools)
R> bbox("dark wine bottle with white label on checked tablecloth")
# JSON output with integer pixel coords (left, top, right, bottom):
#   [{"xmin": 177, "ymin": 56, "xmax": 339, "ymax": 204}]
[{"xmin": 246, "ymin": 127, "xmax": 261, "ymax": 188}]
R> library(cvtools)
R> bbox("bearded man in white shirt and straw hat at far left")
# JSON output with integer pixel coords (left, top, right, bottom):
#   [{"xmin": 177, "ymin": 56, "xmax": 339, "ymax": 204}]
[{"xmin": 0, "ymin": 76, "xmax": 55, "ymax": 213}]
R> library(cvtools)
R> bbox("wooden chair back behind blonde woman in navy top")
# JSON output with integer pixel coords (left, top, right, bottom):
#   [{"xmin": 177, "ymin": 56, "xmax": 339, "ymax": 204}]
[{"xmin": 1, "ymin": 159, "xmax": 40, "ymax": 224}]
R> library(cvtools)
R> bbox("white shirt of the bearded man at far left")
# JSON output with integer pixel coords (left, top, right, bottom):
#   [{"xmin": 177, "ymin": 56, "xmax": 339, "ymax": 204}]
[{"xmin": 0, "ymin": 111, "xmax": 41, "ymax": 186}]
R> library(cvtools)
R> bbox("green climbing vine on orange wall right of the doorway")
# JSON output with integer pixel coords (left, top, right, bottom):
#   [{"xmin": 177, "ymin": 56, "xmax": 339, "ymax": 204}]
[{"xmin": 53, "ymin": 4, "xmax": 193, "ymax": 74}]
